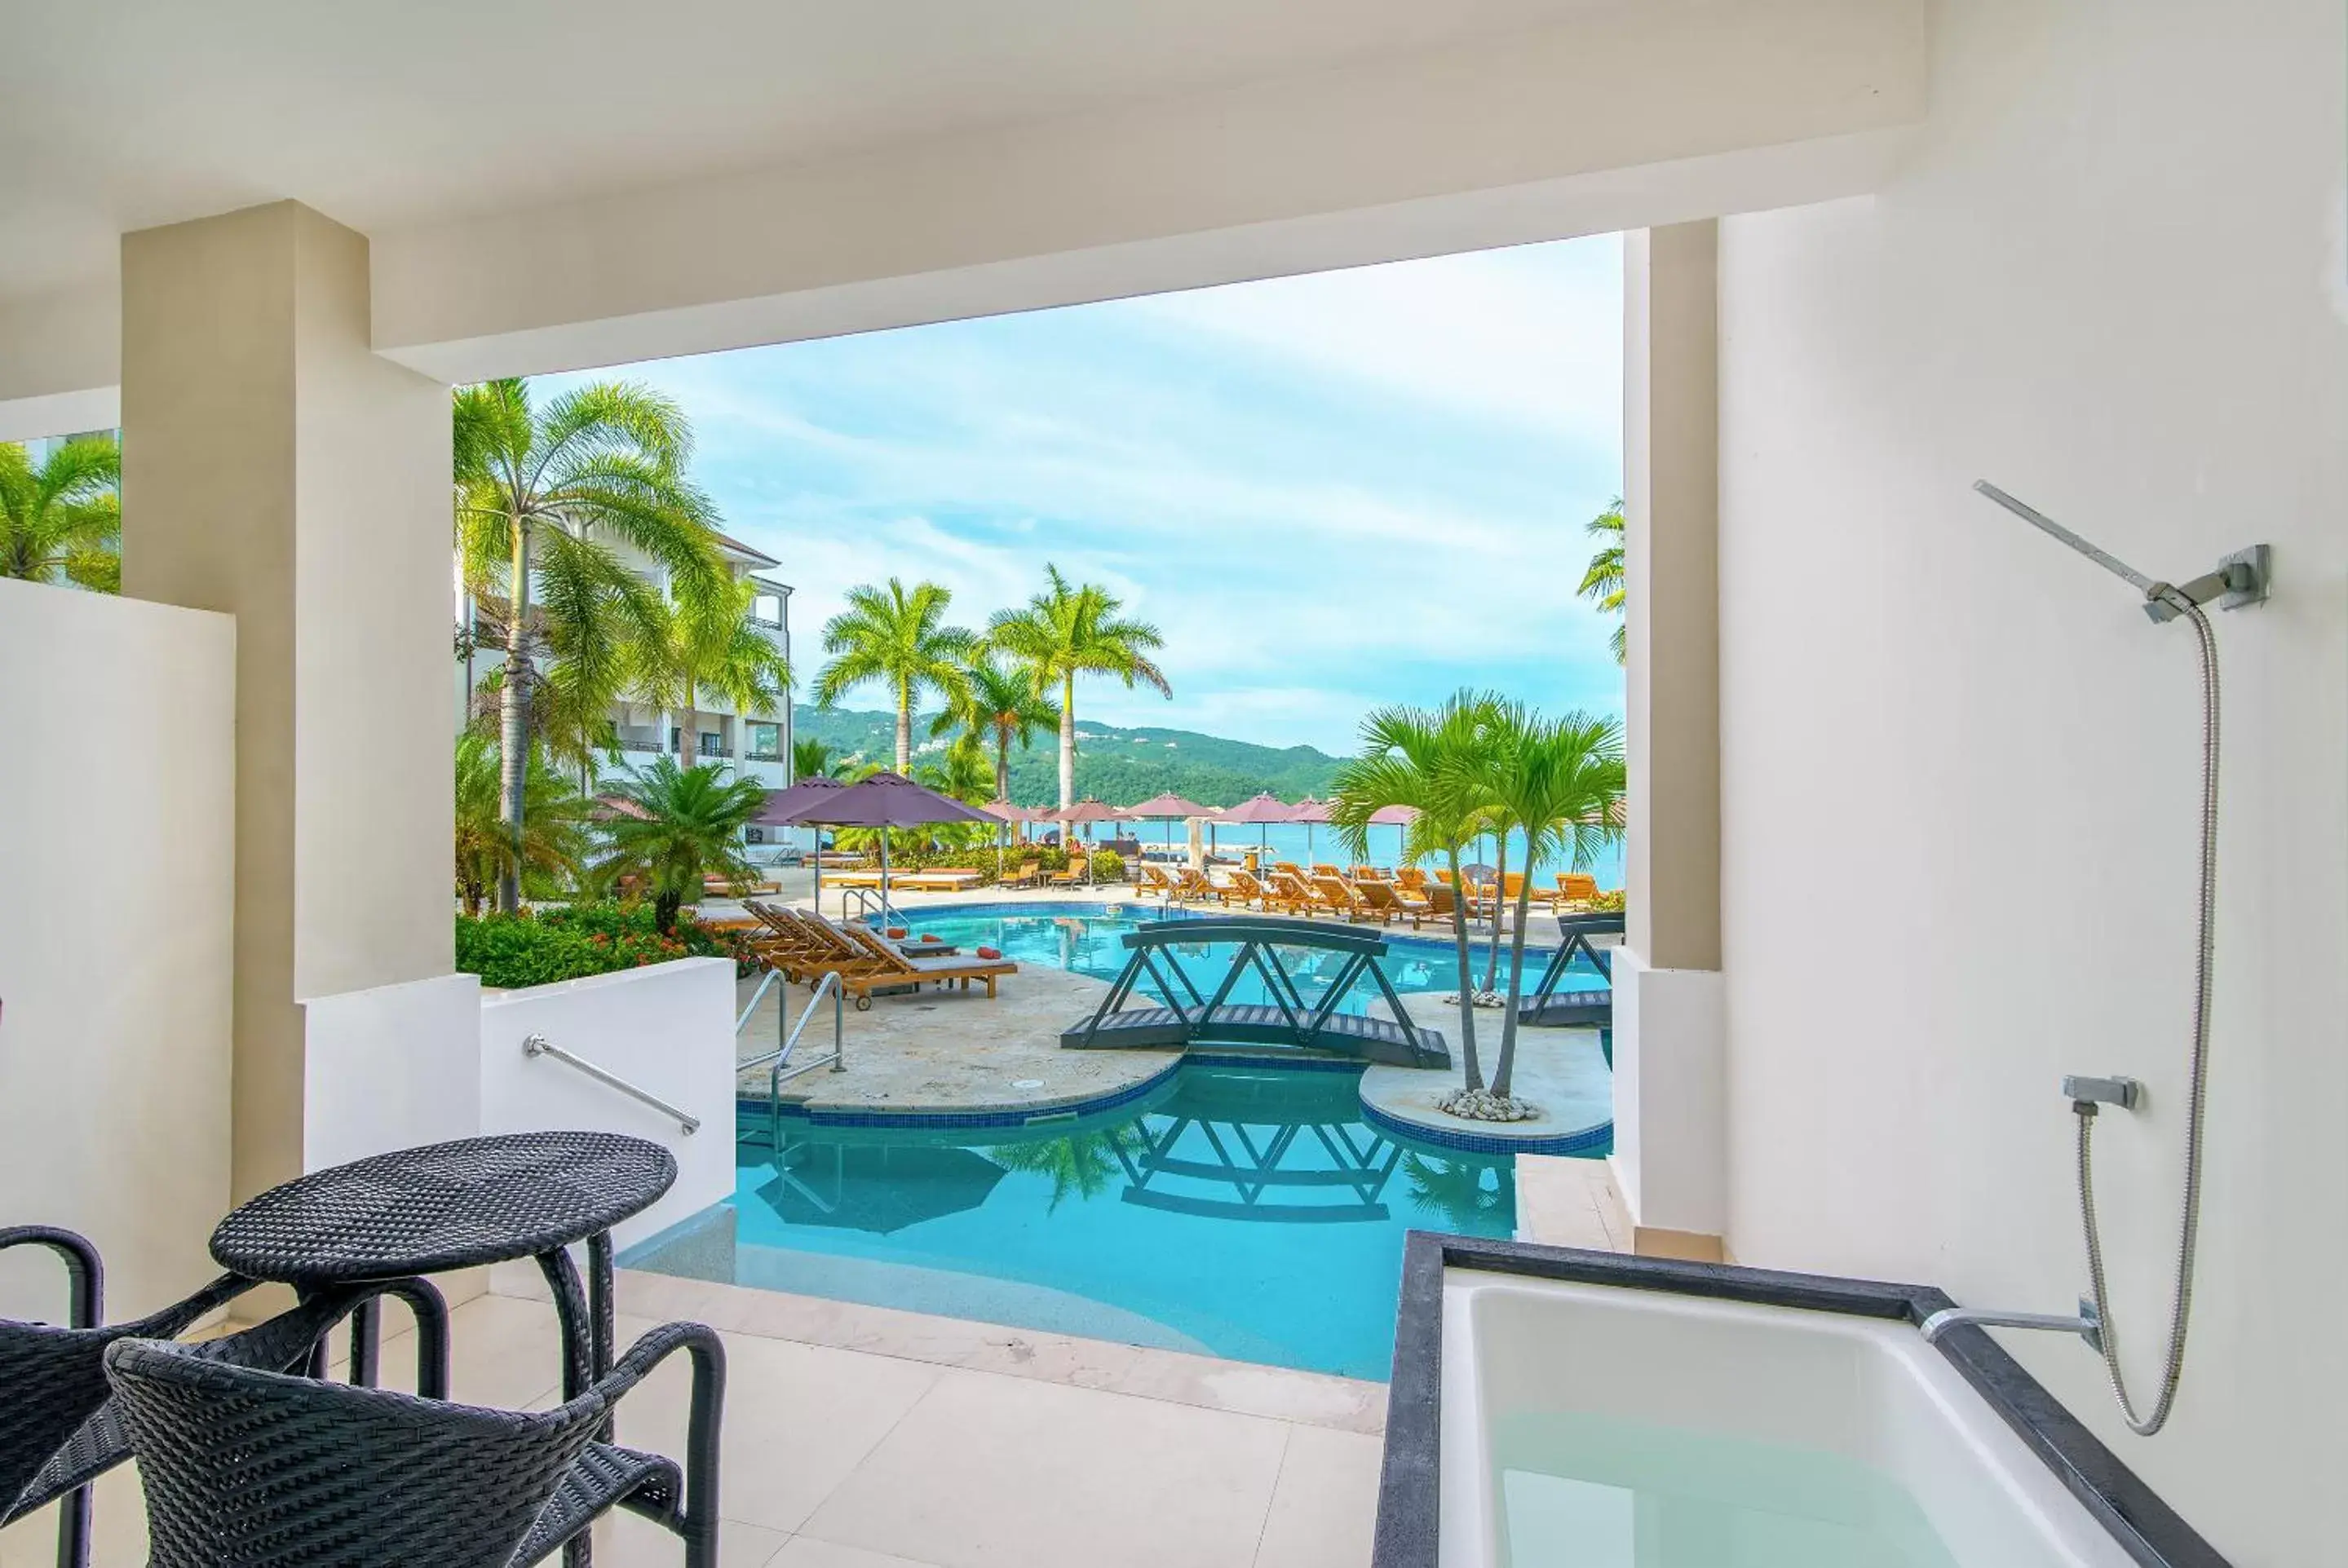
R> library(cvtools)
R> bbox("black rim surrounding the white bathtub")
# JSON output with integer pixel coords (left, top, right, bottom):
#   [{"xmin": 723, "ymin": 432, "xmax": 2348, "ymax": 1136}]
[{"xmin": 1371, "ymin": 1230, "xmax": 2228, "ymax": 1568}]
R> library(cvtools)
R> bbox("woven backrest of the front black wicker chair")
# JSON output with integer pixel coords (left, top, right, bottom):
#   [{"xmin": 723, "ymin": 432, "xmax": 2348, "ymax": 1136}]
[{"xmin": 106, "ymin": 1341, "xmax": 606, "ymax": 1568}]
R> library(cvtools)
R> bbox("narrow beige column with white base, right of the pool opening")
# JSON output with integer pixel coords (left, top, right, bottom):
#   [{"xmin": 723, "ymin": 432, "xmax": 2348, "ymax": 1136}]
[{"xmin": 1616, "ymin": 221, "xmax": 1726, "ymax": 1256}]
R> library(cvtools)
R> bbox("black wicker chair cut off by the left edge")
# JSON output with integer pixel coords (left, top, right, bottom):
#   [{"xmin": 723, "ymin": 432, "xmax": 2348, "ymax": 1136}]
[{"xmin": 0, "ymin": 1226, "xmax": 449, "ymax": 1568}]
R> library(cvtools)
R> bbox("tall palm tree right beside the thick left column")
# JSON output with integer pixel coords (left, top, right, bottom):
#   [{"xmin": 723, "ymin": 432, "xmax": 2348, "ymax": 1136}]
[{"xmin": 453, "ymin": 380, "xmax": 726, "ymax": 908}]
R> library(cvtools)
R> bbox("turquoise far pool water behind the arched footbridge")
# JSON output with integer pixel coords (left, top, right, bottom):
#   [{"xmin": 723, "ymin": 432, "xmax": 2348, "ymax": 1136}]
[{"xmin": 882, "ymin": 901, "xmax": 1606, "ymax": 1014}]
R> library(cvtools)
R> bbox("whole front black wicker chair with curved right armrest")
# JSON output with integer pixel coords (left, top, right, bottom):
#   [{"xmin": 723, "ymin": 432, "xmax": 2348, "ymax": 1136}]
[{"xmin": 106, "ymin": 1324, "xmax": 726, "ymax": 1568}]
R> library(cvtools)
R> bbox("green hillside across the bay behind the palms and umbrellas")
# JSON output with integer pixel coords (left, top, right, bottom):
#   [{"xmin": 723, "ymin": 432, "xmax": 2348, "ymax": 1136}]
[{"xmin": 791, "ymin": 704, "xmax": 1338, "ymax": 805}]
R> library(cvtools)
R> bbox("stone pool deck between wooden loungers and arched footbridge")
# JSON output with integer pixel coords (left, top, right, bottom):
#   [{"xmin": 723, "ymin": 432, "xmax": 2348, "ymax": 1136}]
[{"xmin": 735, "ymin": 965, "xmax": 1178, "ymax": 1115}]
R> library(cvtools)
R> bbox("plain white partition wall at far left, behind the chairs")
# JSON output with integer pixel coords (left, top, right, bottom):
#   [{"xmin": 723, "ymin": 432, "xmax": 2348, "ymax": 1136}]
[{"xmin": 0, "ymin": 580, "xmax": 235, "ymax": 1319}]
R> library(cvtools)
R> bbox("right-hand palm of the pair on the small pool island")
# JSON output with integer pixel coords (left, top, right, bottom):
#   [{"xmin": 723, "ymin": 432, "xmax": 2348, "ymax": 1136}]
[{"xmin": 1488, "ymin": 702, "xmax": 1625, "ymax": 1098}]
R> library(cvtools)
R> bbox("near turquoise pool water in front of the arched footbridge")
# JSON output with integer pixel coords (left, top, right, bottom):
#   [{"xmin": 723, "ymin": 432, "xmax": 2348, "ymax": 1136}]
[{"xmin": 622, "ymin": 1061, "xmax": 1517, "ymax": 1380}]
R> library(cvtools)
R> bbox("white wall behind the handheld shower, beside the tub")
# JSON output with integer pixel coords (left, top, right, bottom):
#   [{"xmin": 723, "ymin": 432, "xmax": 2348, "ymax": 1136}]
[{"xmin": 1721, "ymin": 0, "xmax": 2348, "ymax": 1568}]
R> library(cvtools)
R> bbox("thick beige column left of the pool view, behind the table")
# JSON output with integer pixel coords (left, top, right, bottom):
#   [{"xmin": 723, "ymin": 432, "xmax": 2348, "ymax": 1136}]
[{"xmin": 122, "ymin": 202, "xmax": 453, "ymax": 1197}]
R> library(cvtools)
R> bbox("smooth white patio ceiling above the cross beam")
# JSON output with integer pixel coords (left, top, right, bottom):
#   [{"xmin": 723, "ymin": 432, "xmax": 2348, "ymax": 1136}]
[{"xmin": 0, "ymin": 0, "xmax": 1634, "ymax": 296}]
